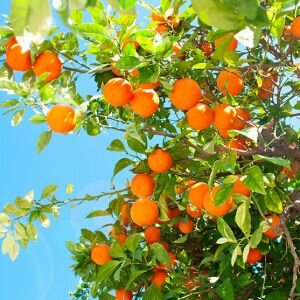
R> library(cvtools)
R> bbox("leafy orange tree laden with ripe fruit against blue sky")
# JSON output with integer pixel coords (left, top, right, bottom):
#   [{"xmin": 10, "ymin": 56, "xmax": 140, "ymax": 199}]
[{"xmin": 0, "ymin": 0, "xmax": 300, "ymax": 300}]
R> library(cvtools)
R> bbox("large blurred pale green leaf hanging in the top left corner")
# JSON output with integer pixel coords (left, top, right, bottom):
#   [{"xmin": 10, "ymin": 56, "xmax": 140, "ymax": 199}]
[{"xmin": 11, "ymin": 0, "xmax": 52, "ymax": 44}]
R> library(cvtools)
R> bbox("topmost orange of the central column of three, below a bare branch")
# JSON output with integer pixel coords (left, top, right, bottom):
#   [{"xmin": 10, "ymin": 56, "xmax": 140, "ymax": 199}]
[{"xmin": 148, "ymin": 149, "xmax": 173, "ymax": 173}]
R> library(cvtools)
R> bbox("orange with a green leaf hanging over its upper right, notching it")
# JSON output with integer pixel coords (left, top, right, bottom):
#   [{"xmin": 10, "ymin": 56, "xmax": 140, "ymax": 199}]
[{"xmin": 203, "ymin": 186, "xmax": 233, "ymax": 217}]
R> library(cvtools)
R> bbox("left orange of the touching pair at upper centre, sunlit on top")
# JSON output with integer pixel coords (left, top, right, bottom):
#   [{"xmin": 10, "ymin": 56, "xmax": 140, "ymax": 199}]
[{"xmin": 103, "ymin": 78, "xmax": 133, "ymax": 107}]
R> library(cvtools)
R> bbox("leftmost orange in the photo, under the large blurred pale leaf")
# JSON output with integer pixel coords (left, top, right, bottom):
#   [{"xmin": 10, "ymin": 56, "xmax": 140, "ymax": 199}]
[{"xmin": 5, "ymin": 37, "xmax": 32, "ymax": 72}]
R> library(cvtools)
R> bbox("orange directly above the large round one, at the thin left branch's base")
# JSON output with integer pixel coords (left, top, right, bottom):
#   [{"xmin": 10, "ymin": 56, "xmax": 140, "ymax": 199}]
[{"xmin": 130, "ymin": 174, "xmax": 155, "ymax": 197}]
